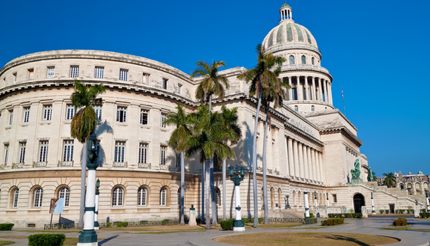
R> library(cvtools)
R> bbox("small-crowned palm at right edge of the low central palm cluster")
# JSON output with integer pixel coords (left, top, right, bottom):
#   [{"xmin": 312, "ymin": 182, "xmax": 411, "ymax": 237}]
[{"xmin": 220, "ymin": 106, "xmax": 241, "ymax": 220}]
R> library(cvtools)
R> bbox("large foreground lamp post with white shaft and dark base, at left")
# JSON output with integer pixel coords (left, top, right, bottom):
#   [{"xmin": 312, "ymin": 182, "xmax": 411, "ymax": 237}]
[{"xmin": 77, "ymin": 135, "xmax": 99, "ymax": 246}]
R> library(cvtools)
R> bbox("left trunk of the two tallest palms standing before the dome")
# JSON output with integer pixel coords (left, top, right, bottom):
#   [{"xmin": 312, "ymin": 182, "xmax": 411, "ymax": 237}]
[{"xmin": 252, "ymin": 94, "xmax": 261, "ymax": 228}]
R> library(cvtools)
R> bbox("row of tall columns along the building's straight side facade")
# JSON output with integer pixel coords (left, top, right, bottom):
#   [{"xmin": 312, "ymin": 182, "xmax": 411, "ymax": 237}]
[{"xmin": 285, "ymin": 136, "xmax": 323, "ymax": 182}]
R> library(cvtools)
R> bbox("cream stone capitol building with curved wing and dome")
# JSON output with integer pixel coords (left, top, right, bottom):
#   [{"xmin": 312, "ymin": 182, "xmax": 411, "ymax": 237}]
[{"xmin": 0, "ymin": 5, "xmax": 424, "ymax": 227}]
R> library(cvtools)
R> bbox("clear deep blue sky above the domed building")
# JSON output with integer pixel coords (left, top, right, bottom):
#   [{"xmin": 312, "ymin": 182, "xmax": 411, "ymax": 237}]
[{"xmin": 0, "ymin": 0, "xmax": 430, "ymax": 174}]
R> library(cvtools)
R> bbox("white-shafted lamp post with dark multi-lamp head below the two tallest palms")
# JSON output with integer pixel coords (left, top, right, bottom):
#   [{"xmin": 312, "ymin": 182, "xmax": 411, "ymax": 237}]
[{"xmin": 228, "ymin": 165, "xmax": 248, "ymax": 231}]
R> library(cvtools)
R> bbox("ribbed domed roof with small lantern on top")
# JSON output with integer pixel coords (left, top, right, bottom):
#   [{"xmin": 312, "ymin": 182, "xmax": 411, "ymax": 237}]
[{"xmin": 262, "ymin": 7, "xmax": 319, "ymax": 52}]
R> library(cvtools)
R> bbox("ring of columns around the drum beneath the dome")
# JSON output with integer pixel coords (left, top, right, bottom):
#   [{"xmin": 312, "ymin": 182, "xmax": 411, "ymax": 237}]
[{"xmin": 283, "ymin": 76, "xmax": 333, "ymax": 105}]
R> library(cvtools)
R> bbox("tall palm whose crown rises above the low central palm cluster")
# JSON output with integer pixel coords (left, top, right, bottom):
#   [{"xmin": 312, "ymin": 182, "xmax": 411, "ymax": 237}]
[{"xmin": 191, "ymin": 61, "xmax": 229, "ymax": 225}]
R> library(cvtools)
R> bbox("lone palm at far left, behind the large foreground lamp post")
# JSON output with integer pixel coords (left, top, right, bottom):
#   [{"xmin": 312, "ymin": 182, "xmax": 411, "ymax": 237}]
[{"xmin": 70, "ymin": 81, "xmax": 105, "ymax": 227}]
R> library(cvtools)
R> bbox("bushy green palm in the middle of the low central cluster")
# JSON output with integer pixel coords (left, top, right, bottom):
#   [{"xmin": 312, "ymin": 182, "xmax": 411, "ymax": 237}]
[{"xmin": 187, "ymin": 105, "xmax": 234, "ymax": 228}]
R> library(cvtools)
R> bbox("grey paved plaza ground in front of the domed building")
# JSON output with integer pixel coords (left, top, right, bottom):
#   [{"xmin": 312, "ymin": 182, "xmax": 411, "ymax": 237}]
[{"xmin": 0, "ymin": 217, "xmax": 430, "ymax": 246}]
